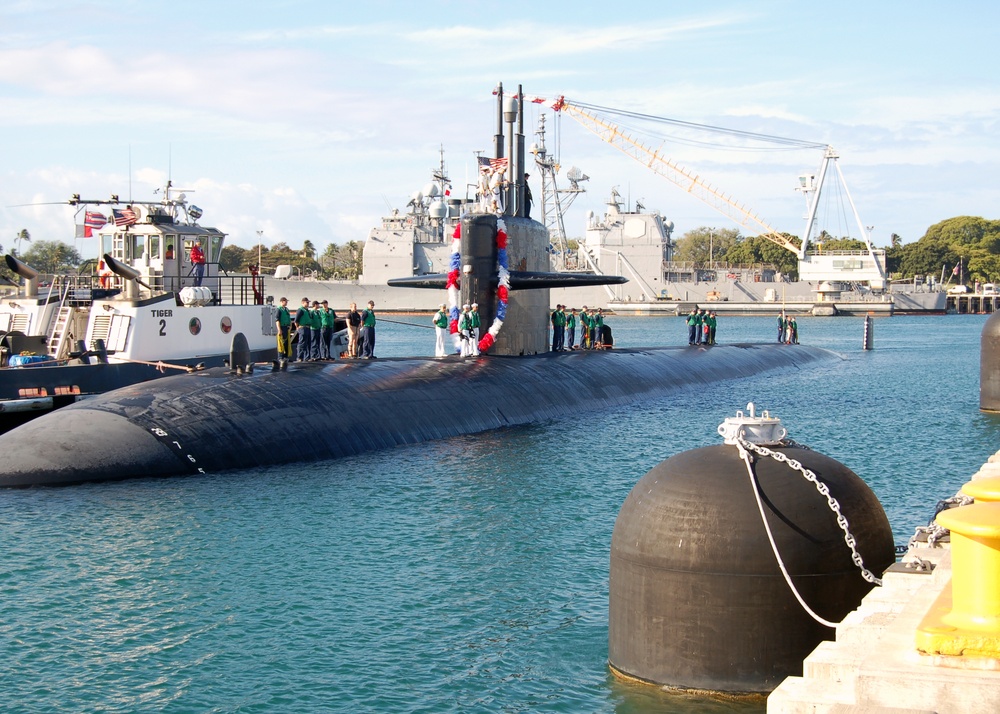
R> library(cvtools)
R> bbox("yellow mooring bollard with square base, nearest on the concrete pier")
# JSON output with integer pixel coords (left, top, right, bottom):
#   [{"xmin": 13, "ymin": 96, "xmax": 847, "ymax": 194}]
[{"xmin": 917, "ymin": 503, "xmax": 1000, "ymax": 658}]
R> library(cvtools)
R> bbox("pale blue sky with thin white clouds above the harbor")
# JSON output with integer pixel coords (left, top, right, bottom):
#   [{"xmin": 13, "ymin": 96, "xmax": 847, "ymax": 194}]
[{"xmin": 0, "ymin": 0, "xmax": 1000, "ymax": 256}]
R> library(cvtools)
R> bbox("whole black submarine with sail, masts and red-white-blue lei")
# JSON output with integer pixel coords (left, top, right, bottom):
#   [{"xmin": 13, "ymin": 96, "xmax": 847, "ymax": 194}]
[{"xmin": 0, "ymin": 83, "xmax": 836, "ymax": 487}]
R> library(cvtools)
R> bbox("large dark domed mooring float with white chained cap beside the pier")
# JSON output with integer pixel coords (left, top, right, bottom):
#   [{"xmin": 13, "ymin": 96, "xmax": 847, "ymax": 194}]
[{"xmin": 608, "ymin": 404, "xmax": 895, "ymax": 693}]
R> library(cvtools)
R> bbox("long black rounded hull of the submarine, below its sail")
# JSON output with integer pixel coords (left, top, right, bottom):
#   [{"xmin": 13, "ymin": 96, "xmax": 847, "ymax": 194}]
[{"xmin": 0, "ymin": 345, "xmax": 836, "ymax": 487}]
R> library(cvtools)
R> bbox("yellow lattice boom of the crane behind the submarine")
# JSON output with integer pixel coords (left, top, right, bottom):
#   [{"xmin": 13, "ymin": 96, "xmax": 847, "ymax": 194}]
[{"xmin": 556, "ymin": 98, "xmax": 805, "ymax": 259}]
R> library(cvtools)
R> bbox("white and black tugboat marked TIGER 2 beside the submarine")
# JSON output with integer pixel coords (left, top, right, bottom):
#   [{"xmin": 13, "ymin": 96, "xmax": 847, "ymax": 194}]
[{"xmin": 0, "ymin": 183, "xmax": 332, "ymax": 432}]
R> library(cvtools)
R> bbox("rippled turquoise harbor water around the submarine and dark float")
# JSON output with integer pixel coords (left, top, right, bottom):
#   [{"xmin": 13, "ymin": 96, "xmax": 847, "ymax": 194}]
[{"xmin": 0, "ymin": 316, "xmax": 1000, "ymax": 713}]
